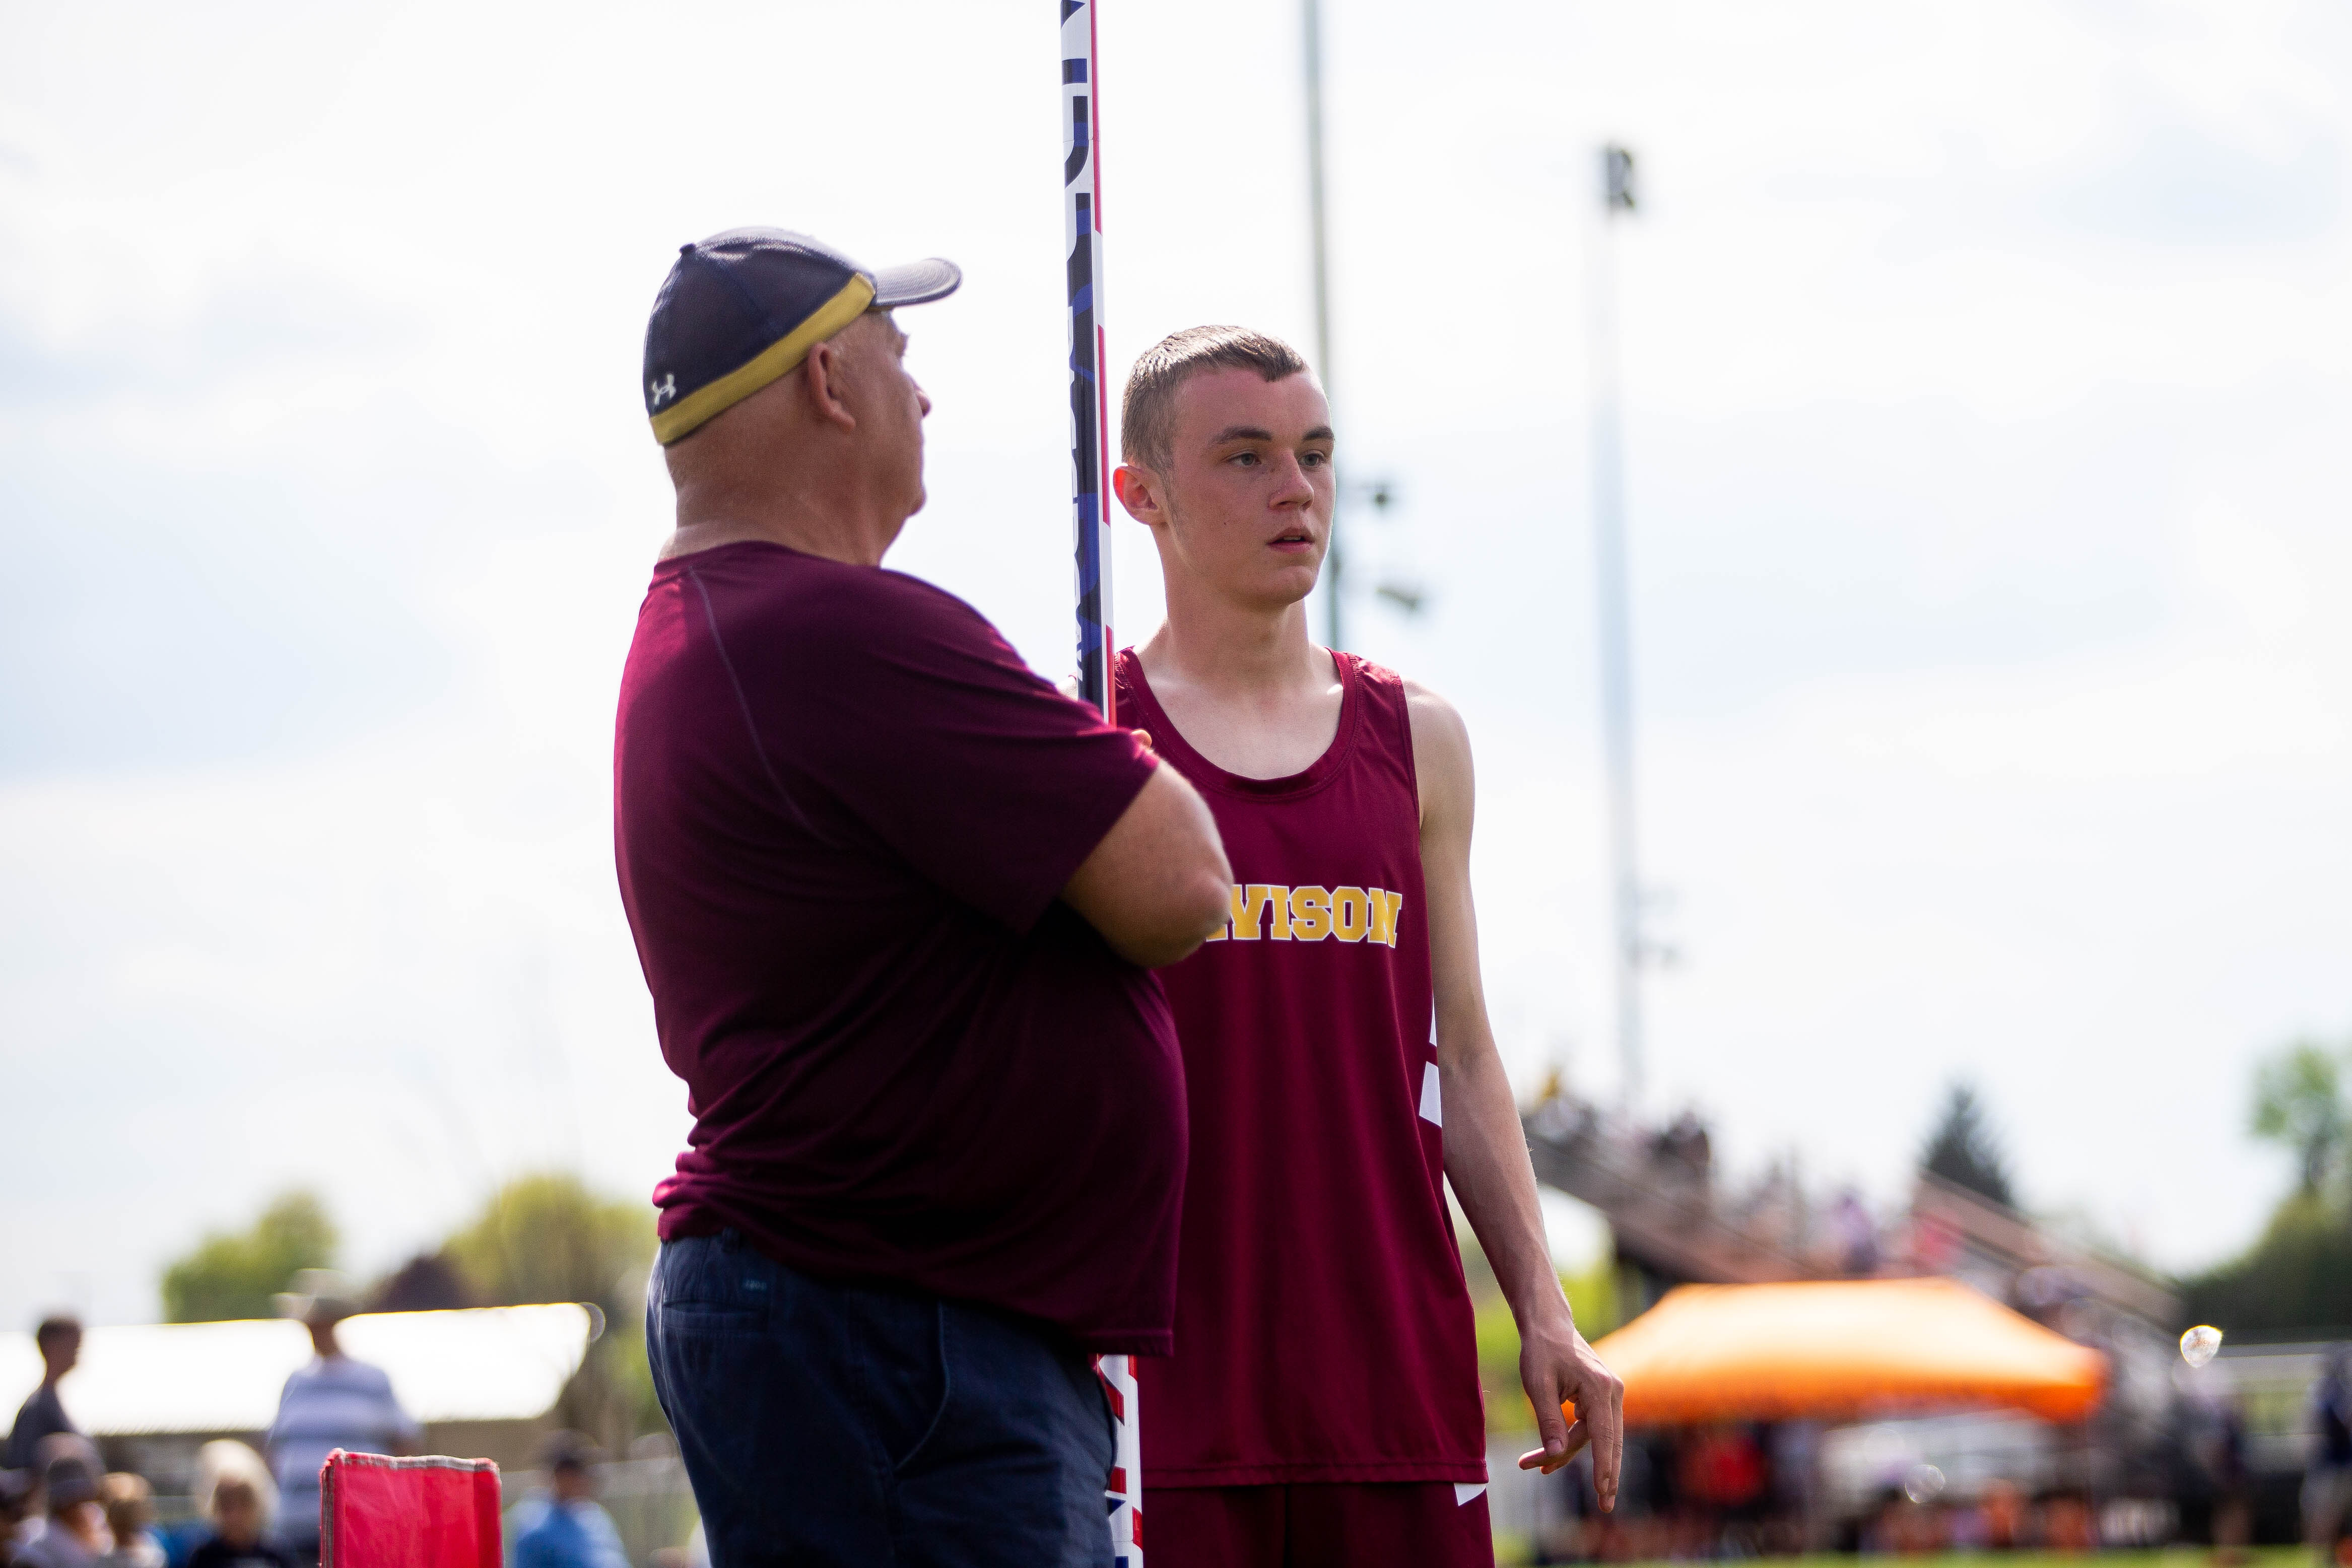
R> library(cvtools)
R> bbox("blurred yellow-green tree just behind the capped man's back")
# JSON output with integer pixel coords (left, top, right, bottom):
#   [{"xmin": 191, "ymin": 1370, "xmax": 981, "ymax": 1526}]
[{"xmin": 440, "ymin": 1173, "xmax": 661, "ymax": 1451}]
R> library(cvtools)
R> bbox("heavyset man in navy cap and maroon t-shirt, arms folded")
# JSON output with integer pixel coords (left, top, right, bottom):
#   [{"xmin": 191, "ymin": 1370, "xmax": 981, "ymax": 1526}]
[{"xmin": 614, "ymin": 228, "xmax": 1230, "ymax": 1568}]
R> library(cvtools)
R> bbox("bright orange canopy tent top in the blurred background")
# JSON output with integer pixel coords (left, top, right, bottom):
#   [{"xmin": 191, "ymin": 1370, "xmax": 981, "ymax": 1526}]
[{"xmin": 1595, "ymin": 1279, "xmax": 2107, "ymax": 1427}]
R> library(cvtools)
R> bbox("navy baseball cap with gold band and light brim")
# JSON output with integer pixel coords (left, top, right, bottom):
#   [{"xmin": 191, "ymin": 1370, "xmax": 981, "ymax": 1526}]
[{"xmin": 644, "ymin": 228, "xmax": 964, "ymax": 447}]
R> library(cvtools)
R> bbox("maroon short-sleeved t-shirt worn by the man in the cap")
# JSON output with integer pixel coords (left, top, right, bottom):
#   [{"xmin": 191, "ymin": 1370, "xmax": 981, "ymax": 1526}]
[{"xmin": 614, "ymin": 543, "xmax": 1185, "ymax": 1354}]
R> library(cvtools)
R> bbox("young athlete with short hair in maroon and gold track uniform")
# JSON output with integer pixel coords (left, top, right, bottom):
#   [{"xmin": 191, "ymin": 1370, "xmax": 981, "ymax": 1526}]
[{"xmin": 1115, "ymin": 327, "xmax": 1623, "ymax": 1568}]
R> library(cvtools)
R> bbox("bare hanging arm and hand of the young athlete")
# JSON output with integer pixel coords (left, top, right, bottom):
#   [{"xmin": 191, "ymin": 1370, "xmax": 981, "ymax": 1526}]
[{"xmin": 1406, "ymin": 681, "xmax": 1625, "ymax": 1509}]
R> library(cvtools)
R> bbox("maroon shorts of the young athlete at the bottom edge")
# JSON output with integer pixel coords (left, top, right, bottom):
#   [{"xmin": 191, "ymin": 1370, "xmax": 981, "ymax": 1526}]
[{"xmin": 1143, "ymin": 1481, "xmax": 1494, "ymax": 1568}]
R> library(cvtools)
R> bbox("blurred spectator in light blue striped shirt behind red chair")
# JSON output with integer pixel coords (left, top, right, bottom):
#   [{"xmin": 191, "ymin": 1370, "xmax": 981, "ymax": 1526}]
[{"xmin": 268, "ymin": 1269, "xmax": 421, "ymax": 1558}]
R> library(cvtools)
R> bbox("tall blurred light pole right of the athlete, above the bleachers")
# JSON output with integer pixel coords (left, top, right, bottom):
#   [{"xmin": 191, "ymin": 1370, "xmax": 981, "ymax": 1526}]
[{"xmin": 1592, "ymin": 146, "xmax": 1644, "ymax": 1110}]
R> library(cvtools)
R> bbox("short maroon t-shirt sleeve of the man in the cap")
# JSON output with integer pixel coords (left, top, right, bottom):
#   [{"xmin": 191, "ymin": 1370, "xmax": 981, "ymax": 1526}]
[{"xmin": 720, "ymin": 569, "xmax": 1155, "ymax": 931}]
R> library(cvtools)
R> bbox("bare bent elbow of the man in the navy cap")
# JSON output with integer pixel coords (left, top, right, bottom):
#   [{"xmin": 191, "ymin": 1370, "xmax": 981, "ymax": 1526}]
[{"xmin": 1061, "ymin": 766, "xmax": 1233, "ymax": 969}]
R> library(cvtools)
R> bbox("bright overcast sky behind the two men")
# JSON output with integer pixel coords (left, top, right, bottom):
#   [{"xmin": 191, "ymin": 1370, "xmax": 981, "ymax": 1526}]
[{"xmin": 0, "ymin": 0, "xmax": 2352, "ymax": 1326}]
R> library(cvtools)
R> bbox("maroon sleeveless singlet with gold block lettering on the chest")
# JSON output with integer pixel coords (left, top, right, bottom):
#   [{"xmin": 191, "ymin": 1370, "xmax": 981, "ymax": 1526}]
[{"xmin": 1117, "ymin": 649, "xmax": 1487, "ymax": 1488}]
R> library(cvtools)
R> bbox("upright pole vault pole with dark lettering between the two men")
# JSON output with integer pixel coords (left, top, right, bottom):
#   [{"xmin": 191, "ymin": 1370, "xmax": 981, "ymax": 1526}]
[{"xmin": 1056, "ymin": 0, "xmax": 1143, "ymax": 1568}]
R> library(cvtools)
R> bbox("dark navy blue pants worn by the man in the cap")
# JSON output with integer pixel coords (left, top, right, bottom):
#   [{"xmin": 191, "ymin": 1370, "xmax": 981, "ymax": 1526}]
[{"xmin": 644, "ymin": 1230, "xmax": 1112, "ymax": 1568}]
